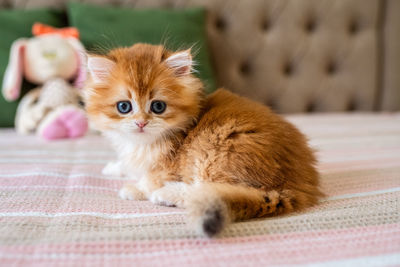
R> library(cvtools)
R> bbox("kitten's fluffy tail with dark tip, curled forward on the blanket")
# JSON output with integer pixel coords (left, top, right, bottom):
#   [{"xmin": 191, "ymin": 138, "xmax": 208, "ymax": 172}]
[{"xmin": 186, "ymin": 183, "xmax": 316, "ymax": 237}]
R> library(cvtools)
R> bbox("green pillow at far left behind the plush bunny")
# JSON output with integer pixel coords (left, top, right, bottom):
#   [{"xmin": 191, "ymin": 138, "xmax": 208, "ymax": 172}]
[{"xmin": 0, "ymin": 9, "xmax": 66, "ymax": 127}]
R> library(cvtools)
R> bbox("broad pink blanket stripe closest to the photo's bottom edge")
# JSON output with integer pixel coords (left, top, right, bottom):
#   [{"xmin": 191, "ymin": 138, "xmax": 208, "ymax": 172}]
[{"xmin": 0, "ymin": 224, "xmax": 400, "ymax": 266}]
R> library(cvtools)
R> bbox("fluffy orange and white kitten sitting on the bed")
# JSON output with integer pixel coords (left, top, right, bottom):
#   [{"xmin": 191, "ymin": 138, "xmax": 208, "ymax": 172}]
[{"xmin": 86, "ymin": 44, "xmax": 322, "ymax": 239}]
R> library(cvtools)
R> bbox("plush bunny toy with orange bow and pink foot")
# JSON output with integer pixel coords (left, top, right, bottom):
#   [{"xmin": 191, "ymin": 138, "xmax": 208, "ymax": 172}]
[{"xmin": 3, "ymin": 23, "xmax": 88, "ymax": 140}]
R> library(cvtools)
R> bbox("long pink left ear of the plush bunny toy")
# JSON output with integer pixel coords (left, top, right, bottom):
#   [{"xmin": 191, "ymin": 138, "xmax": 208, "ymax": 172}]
[{"xmin": 2, "ymin": 38, "xmax": 27, "ymax": 101}]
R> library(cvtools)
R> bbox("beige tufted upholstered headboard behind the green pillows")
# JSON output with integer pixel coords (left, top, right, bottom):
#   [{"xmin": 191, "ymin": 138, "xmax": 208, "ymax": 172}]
[{"xmin": 0, "ymin": 0, "xmax": 400, "ymax": 113}]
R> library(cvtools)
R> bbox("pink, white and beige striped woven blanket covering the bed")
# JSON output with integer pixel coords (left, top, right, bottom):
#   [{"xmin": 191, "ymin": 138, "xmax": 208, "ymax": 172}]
[{"xmin": 0, "ymin": 113, "xmax": 400, "ymax": 267}]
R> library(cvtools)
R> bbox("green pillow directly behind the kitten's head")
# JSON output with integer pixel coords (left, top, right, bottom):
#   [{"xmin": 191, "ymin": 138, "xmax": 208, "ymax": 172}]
[{"xmin": 68, "ymin": 2, "xmax": 215, "ymax": 92}]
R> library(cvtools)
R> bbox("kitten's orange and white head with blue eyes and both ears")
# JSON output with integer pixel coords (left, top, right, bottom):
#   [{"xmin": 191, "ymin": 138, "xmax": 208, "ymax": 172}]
[{"xmin": 86, "ymin": 44, "xmax": 202, "ymax": 143}]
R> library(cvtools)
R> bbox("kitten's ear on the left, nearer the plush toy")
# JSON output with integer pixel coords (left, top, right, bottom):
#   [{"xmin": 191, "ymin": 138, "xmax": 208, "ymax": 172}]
[{"xmin": 87, "ymin": 56, "xmax": 115, "ymax": 83}]
